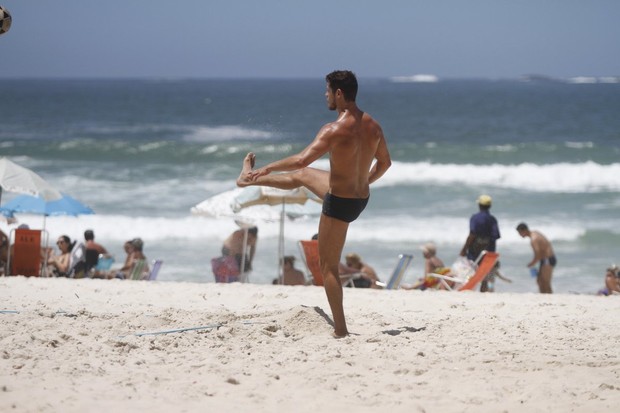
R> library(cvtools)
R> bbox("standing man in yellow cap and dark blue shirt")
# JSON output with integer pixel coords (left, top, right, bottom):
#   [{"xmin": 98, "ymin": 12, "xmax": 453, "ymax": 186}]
[{"xmin": 461, "ymin": 195, "xmax": 500, "ymax": 292}]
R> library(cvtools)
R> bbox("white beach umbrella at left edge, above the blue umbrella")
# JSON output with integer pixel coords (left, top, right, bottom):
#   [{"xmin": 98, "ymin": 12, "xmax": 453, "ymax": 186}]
[{"xmin": 0, "ymin": 158, "xmax": 62, "ymax": 201}]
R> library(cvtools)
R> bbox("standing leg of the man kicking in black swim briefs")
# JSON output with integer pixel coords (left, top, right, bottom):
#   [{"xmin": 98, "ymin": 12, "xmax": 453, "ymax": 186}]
[{"xmin": 319, "ymin": 214, "xmax": 349, "ymax": 337}]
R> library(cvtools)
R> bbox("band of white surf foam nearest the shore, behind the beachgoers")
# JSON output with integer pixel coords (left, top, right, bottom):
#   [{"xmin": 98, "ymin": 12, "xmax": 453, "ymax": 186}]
[{"xmin": 0, "ymin": 208, "xmax": 596, "ymax": 251}]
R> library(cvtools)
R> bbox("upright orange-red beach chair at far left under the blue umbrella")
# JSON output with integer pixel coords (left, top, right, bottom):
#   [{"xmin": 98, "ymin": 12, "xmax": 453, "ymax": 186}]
[{"xmin": 7, "ymin": 228, "xmax": 47, "ymax": 277}]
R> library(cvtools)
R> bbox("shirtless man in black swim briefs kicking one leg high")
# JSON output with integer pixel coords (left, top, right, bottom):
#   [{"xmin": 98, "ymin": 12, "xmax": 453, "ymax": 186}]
[{"xmin": 237, "ymin": 71, "xmax": 392, "ymax": 337}]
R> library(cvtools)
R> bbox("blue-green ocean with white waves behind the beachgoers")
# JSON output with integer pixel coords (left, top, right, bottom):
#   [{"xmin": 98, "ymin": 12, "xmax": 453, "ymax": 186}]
[{"xmin": 0, "ymin": 79, "xmax": 620, "ymax": 293}]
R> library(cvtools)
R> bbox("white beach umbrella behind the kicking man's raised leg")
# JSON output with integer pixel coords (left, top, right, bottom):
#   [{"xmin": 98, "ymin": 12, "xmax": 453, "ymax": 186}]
[{"xmin": 192, "ymin": 186, "xmax": 323, "ymax": 277}]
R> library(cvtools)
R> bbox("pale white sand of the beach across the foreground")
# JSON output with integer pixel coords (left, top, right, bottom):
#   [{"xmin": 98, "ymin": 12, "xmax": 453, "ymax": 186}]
[{"xmin": 0, "ymin": 277, "xmax": 620, "ymax": 413}]
